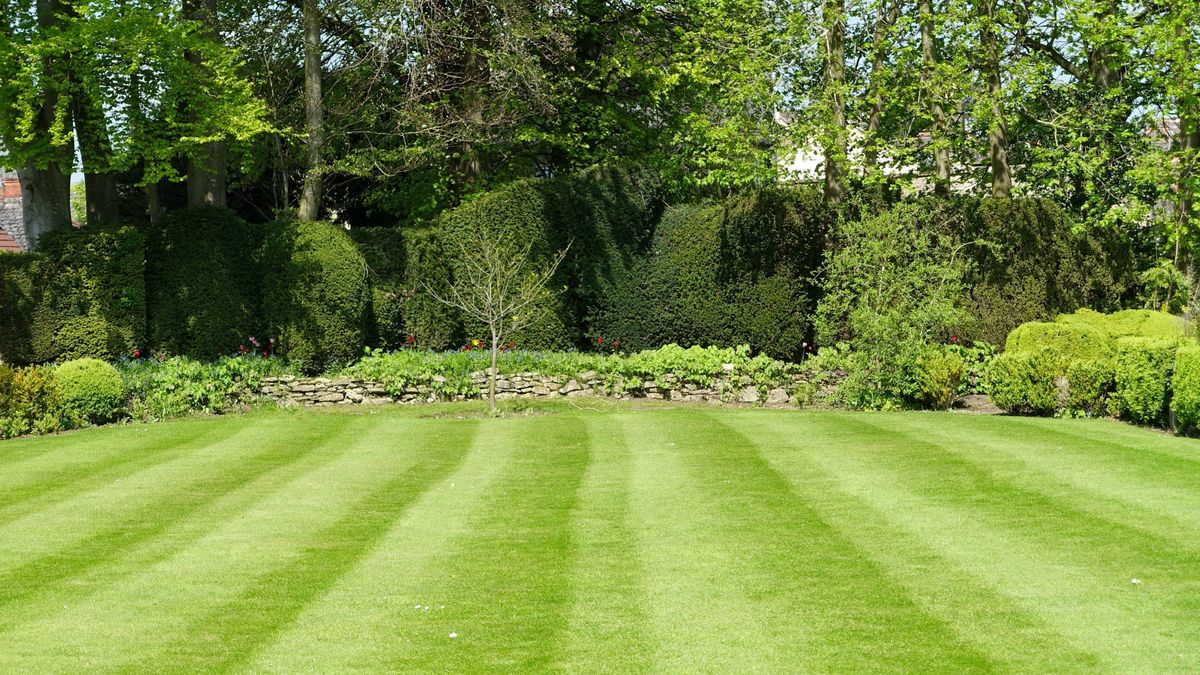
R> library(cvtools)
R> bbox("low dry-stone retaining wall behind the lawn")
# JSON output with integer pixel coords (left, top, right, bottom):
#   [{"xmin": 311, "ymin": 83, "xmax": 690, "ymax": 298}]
[{"xmin": 260, "ymin": 372, "xmax": 806, "ymax": 406}]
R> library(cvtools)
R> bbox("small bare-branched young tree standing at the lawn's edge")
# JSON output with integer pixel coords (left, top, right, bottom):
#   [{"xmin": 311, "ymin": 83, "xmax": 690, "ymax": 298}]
[{"xmin": 425, "ymin": 219, "xmax": 570, "ymax": 414}]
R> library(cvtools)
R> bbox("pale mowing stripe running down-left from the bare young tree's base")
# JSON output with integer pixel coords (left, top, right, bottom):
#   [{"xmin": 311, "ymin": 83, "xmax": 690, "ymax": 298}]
[{"xmin": 247, "ymin": 418, "xmax": 520, "ymax": 673}]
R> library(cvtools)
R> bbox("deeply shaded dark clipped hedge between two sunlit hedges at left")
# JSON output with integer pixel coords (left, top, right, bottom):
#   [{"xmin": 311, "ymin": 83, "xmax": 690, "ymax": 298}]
[{"xmin": 146, "ymin": 207, "xmax": 263, "ymax": 359}]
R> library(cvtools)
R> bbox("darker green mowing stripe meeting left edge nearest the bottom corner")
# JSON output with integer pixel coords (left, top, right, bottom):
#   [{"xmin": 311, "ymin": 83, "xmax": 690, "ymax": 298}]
[{"xmin": 0, "ymin": 417, "xmax": 362, "ymax": 629}]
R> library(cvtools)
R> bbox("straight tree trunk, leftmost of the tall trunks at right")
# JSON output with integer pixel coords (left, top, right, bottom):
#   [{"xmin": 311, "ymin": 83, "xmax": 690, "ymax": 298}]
[{"xmin": 822, "ymin": 0, "xmax": 848, "ymax": 204}]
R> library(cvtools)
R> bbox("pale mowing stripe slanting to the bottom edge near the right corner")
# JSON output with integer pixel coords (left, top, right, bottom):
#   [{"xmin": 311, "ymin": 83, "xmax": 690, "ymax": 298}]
[{"xmin": 737, "ymin": 413, "xmax": 1100, "ymax": 673}]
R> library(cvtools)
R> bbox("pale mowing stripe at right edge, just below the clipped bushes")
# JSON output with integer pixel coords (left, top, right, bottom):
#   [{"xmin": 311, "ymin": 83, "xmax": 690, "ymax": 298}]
[{"xmin": 896, "ymin": 419, "xmax": 1200, "ymax": 549}]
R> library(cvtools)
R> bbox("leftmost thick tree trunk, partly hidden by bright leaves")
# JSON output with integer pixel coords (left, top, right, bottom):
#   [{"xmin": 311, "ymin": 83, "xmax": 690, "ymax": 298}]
[{"xmin": 17, "ymin": 0, "xmax": 74, "ymax": 249}]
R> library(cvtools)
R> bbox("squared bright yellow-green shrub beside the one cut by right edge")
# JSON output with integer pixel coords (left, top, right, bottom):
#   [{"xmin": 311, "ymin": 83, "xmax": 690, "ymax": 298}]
[{"xmin": 1114, "ymin": 338, "xmax": 1176, "ymax": 424}]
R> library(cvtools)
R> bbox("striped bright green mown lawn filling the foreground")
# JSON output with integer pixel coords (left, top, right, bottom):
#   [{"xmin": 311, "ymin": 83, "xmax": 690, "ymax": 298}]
[{"xmin": 0, "ymin": 407, "xmax": 1200, "ymax": 673}]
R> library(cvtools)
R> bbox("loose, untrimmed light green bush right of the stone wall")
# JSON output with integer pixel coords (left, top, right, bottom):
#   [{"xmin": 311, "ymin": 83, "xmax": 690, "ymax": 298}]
[{"xmin": 816, "ymin": 204, "xmax": 971, "ymax": 408}]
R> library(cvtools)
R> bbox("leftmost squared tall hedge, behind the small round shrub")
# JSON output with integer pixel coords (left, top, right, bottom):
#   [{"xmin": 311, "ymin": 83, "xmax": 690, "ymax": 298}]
[{"xmin": 0, "ymin": 227, "xmax": 145, "ymax": 363}]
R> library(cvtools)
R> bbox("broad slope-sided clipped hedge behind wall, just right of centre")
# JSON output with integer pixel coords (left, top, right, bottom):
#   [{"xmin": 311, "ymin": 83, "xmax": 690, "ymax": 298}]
[{"xmin": 594, "ymin": 181, "xmax": 828, "ymax": 360}]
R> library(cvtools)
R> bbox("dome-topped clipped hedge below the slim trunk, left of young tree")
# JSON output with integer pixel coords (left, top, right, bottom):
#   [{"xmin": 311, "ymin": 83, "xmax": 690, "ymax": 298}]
[{"xmin": 262, "ymin": 220, "xmax": 367, "ymax": 372}]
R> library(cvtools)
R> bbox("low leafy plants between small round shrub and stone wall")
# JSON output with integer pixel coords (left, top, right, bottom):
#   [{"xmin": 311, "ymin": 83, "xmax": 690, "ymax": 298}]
[{"xmin": 120, "ymin": 356, "xmax": 290, "ymax": 420}]
